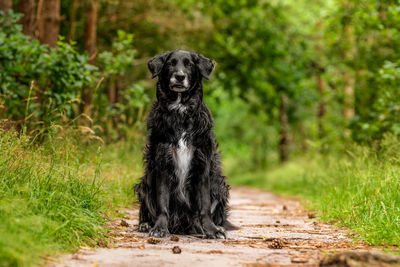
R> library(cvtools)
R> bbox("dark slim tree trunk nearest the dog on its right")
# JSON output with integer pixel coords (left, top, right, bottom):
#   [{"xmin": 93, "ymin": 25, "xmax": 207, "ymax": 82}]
[{"xmin": 279, "ymin": 94, "xmax": 290, "ymax": 162}]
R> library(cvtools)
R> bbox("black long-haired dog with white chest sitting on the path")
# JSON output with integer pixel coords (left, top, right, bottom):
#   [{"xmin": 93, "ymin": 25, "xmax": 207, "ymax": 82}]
[{"xmin": 135, "ymin": 50, "xmax": 235, "ymax": 238}]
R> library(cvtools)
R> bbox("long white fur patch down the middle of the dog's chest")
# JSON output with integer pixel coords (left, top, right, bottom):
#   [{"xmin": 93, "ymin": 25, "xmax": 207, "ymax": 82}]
[{"xmin": 174, "ymin": 132, "xmax": 193, "ymax": 203}]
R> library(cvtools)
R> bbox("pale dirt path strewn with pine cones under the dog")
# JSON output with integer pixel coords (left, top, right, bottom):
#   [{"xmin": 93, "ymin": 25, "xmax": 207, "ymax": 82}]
[{"xmin": 53, "ymin": 187, "xmax": 390, "ymax": 267}]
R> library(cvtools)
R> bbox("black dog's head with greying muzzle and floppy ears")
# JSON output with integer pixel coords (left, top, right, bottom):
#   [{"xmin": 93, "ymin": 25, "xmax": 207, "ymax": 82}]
[{"xmin": 147, "ymin": 50, "xmax": 216, "ymax": 93}]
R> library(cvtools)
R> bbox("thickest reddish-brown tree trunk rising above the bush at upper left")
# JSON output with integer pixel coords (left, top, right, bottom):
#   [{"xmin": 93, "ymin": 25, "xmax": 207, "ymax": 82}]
[{"xmin": 37, "ymin": 0, "xmax": 60, "ymax": 47}]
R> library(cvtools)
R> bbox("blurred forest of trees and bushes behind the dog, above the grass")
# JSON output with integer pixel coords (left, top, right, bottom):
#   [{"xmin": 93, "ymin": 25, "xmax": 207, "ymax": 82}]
[{"xmin": 0, "ymin": 0, "xmax": 400, "ymax": 169}]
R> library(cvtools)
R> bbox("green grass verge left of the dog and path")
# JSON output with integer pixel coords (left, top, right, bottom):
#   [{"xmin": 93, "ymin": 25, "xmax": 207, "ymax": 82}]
[{"xmin": 0, "ymin": 131, "xmax": 141, "ymax": 266}]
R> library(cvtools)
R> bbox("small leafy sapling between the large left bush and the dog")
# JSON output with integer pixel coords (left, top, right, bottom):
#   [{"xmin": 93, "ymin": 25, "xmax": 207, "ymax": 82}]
[{"xmin": 95, "ymin": 30, "xmax": 150, "ymax": 140}]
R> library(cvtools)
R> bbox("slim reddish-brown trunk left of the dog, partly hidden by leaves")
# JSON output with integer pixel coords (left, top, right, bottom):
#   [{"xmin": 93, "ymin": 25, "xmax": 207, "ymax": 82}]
[{"xmin": 82, "ymin": 0, "xmax": 99, "ymax": 117}]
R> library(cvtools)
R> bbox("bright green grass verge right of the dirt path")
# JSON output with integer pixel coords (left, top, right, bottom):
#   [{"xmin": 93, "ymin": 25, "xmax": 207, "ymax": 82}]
[{"xmin": 231, "ymin": 148, "xmax": 400, "ymax": 246}]
